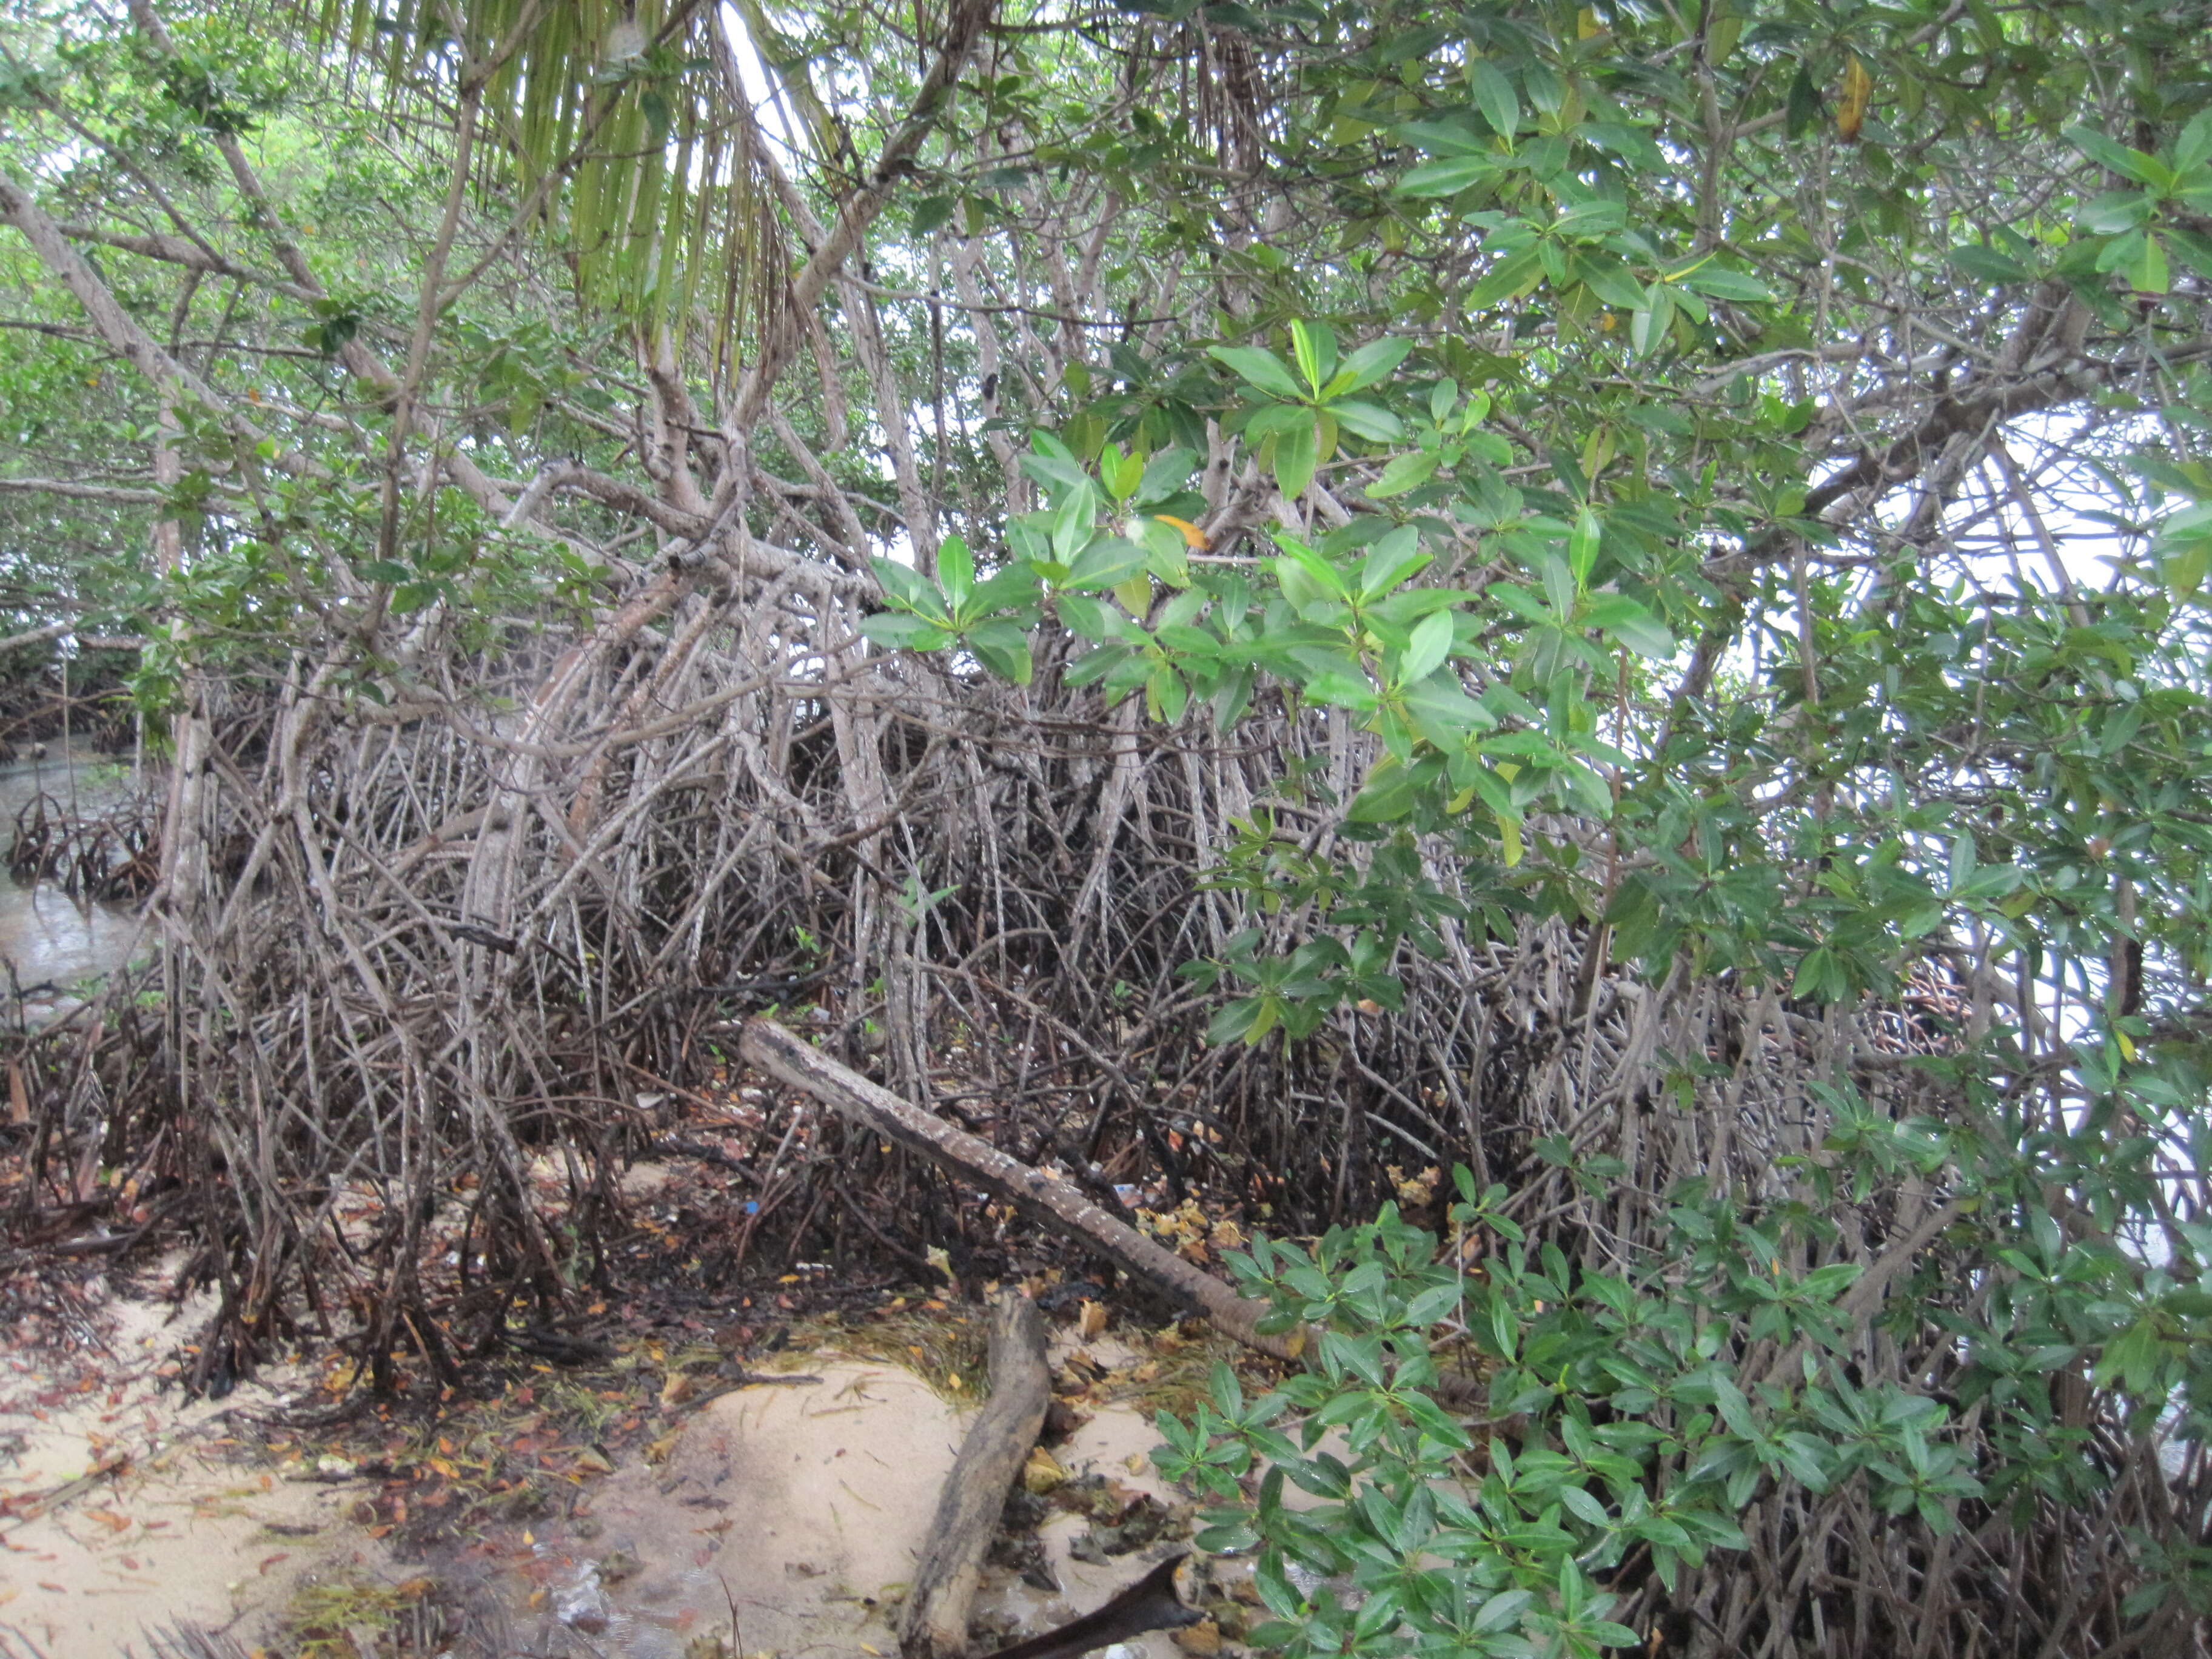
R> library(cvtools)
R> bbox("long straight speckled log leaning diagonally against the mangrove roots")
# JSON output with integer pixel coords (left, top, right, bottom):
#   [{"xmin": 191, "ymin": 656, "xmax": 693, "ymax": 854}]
[{"xmin": 739, "ymin": 1020, "xmax": 1303, "ymax": 1361}]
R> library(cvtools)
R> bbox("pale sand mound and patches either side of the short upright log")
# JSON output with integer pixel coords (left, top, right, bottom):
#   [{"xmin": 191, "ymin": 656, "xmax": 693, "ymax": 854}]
[{"xmin": 431, "ymin": 1358, "xmax": 1212, "ymax": 1659}]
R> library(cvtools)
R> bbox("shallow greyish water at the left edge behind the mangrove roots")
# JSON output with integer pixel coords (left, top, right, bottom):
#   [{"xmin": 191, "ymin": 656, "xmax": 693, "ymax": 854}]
[{"xmin": 0, "ymin": 754, "xmax": 139, "ymax": 1020}]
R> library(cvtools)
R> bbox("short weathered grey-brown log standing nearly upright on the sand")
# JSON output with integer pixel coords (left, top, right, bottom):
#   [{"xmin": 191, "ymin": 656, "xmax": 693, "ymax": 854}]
[{"xmin": 900, "ymin": 1290, "xmax": 1053, "ymax": 1659}]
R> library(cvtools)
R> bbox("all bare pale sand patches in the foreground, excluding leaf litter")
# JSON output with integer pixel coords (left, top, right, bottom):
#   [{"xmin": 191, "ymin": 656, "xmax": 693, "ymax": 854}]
[{"xmin": 0, "ymin": 1301, "xmax": 1221, "ymax": 1659}]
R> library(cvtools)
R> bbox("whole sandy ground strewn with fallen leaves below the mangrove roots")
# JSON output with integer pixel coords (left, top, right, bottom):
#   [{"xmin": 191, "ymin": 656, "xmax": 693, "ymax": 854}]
[{"xmin": 0, "ymin": 1073, "xmax": 1267, "ymax": 1659}]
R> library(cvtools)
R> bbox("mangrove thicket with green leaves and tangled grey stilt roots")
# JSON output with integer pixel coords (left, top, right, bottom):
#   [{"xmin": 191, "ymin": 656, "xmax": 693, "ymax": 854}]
[{"xmin": 0, "ymin": 0, "xmax": 2212, "ymax": 1659}]
